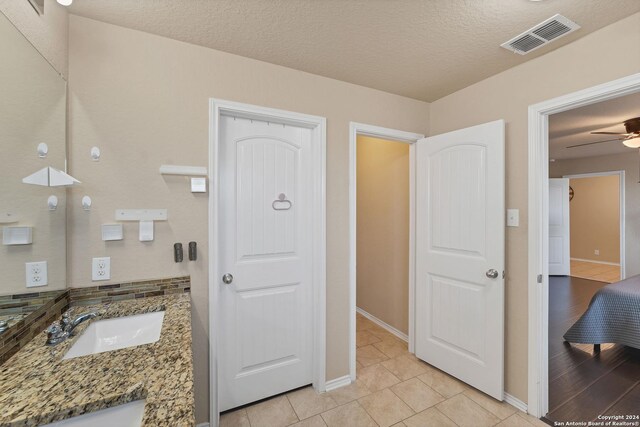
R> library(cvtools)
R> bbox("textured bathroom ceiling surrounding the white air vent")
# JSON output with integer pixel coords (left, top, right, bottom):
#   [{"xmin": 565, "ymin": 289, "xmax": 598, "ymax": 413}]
[{"xmin": 70, "ymin": 0, "xmax": 640, "ymax": 102}]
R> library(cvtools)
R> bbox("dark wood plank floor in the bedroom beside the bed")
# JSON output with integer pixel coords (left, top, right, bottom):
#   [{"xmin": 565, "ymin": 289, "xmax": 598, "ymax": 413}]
[{"xmin": 546, "ymin": 277, "xmax": 640, "ymax": 425}]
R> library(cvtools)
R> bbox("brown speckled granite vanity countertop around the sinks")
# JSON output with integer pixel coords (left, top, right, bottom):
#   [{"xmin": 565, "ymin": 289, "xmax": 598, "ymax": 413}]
[{"xmin": 0, "ymin": 294, "xmax": 195, "ymax": 427}]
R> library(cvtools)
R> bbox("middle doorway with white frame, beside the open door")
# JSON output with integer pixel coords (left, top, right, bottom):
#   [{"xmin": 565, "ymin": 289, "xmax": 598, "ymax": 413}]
[{"xmin": 345, "ymin": 123, "xmax": 424, "ymax": 382}]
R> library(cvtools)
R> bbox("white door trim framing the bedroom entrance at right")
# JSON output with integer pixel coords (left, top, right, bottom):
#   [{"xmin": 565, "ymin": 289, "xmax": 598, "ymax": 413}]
[{"xmin": 527, "ymin": 73, "xmax": 640, "ymax": 417}]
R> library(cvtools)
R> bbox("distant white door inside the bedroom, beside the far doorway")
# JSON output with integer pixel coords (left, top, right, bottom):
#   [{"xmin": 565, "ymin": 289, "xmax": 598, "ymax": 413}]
[{"xmin": 549, "ymin": 178, "xmax": 571, "ymax": 276}]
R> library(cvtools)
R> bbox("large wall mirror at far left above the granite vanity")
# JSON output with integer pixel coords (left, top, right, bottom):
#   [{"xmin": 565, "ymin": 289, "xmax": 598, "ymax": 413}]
[{"xmin": 0, "ymin": 13, "xmax": 67, "ymax": 324}]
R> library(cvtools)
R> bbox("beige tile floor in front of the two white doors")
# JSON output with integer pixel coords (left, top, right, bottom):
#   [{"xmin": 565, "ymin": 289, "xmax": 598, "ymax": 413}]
[{"xmin": 220, "ymin": 314, "xmax": 546, "ymax": 427}]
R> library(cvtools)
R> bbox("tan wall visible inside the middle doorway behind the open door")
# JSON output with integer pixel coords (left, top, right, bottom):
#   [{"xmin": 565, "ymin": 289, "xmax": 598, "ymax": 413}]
[{"xmin": 356, "ymin": 135, "xmax": 409, "ymax": 334}]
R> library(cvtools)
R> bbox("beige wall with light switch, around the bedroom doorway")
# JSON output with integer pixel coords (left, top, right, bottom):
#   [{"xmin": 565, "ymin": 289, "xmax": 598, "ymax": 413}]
[{"xmin": 430, "ymin": 14, "xmax": 640, "ymax": 402}]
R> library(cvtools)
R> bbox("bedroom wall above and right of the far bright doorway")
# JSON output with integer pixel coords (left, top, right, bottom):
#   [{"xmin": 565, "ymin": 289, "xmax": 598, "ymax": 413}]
[{"xmin": 549, "ymin": 153, "xmax": 640, "ymax": 277}]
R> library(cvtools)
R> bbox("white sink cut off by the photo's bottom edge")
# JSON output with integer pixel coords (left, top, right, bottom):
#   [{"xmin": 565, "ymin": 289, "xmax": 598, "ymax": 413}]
[{"xmin": 41, "ymin": 400, "xmax": 145, "ymax": 427}]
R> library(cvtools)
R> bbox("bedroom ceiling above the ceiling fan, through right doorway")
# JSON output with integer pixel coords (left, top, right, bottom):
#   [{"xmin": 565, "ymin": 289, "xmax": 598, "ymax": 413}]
[{"xmin": 549, "ymin": 93, "xmax": 640, "ymax": 159}]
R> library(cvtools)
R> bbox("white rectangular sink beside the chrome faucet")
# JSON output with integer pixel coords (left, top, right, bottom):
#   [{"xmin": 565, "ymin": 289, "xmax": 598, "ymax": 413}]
[{"xmin": 63, "ymin": 311, "xmax": 164, "ymax": 359}]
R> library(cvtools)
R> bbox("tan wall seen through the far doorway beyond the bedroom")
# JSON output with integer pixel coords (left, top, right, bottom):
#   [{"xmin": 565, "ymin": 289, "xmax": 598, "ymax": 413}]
[{"xmin": 569, "ymin": 175, "xmax": 620, "ymax": 264}]
